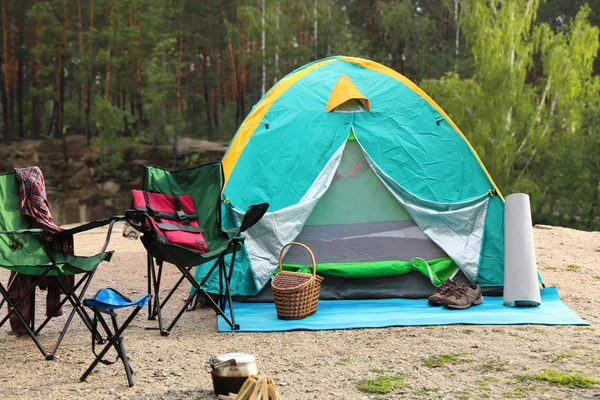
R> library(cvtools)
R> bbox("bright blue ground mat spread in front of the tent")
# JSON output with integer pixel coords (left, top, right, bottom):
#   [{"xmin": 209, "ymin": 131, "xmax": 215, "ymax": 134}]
[{"xmin": 218, "ymin": 286, "xmax": 590, "ymax": 332}]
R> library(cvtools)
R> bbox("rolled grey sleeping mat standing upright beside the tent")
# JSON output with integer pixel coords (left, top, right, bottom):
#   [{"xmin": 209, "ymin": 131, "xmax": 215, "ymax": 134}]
[{"xmin": 503, "ymin": 193, "xmax": 542, "ymax": 307}]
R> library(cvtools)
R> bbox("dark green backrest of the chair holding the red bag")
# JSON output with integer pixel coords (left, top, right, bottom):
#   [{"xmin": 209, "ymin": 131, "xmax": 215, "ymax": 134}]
[{"xmin": 142, "ymin": 162, "xmax": 227, "ymax": 248}]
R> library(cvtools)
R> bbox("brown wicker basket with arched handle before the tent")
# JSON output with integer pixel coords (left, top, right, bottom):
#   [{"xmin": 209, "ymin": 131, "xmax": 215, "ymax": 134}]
[{"xmin": 271, "ymin": 242, "xmax": 323, "ymax": 319}]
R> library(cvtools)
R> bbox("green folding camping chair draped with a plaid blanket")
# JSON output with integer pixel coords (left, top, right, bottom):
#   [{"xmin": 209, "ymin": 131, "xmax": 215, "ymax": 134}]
[{"xmin": 0, "ymin": 172, "xmax": 122, "ymax": 360}]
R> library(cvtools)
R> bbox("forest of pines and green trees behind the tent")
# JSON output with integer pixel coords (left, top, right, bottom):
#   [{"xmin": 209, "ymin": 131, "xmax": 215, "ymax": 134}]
[{"xmin": 0, "ymin": 0, "xmax": 600, "ymax": 230}]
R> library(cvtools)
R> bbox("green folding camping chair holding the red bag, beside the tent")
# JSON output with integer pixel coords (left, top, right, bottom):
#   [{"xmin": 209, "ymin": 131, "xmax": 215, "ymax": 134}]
[{"xmin": 125, "ymin": 162, "xmax": 269, "ymax": 336}]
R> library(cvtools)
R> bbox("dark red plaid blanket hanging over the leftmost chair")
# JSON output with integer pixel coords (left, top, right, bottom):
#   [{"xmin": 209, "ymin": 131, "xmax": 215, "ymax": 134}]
[{"xmin": 8, "ymin": 167, "xmax": 75, "ymax": 335}]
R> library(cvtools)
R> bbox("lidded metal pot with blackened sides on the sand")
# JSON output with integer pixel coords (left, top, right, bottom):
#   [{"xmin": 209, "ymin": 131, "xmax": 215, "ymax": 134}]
[{"xmin": 209, "ymin": 353, "xmax": 258, "ymax": 395}]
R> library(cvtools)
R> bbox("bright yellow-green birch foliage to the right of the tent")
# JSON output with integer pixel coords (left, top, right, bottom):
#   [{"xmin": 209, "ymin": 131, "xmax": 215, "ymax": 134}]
[{"xmin": 423, "ymin": 0, "xmax": 600, "ymax": 229}]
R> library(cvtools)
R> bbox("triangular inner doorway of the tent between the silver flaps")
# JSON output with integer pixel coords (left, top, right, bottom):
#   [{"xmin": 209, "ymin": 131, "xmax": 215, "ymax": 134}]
[{"xmin": 284, "ymin": 139, "xmax": 454, "ymax": 284}]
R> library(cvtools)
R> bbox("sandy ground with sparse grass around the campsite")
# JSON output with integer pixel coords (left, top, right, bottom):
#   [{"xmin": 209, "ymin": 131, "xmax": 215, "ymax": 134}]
[{"xmin": 0, "ymin": 226, "xmax": 600, "ymax": 399}]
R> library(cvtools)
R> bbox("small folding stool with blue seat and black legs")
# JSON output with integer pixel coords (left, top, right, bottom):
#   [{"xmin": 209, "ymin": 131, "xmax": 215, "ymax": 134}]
[{"xmin": 79, "ymin": 288, "xmax": 152, "ymax": 386}]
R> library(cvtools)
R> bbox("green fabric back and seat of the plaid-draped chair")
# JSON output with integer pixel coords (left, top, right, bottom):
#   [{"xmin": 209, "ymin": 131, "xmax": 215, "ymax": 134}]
[{"xmin": 0, "ymin": 171, "xmax": 48, "ymax": 273}]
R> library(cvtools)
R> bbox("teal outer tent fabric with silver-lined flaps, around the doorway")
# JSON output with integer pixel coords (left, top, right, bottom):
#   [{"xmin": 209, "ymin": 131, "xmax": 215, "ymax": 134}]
[{"xmin": 196, "ymin": 57, "xmax": 504, "ymax": 295}]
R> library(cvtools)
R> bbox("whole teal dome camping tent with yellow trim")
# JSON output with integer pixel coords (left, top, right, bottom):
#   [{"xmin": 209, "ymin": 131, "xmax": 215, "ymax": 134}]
[{"xmin": 197, "ymin": 56, "xmax": 504, "ymax": 298}]
